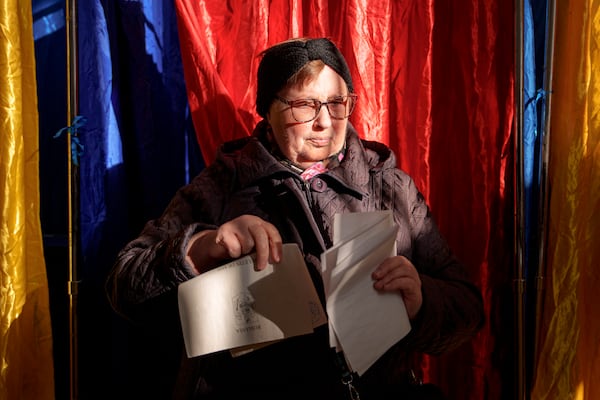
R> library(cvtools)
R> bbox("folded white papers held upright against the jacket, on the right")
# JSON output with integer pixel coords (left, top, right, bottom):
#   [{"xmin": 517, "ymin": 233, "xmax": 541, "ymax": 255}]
[{"xmin": 321, "ymin": 211, "xmax": 410, "ymax": 375}]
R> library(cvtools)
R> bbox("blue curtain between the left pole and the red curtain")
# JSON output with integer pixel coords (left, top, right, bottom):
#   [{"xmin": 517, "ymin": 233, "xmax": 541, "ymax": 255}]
[{"xmin": 77, "ymin": 0, "xmax": 202, "ymax": 398}]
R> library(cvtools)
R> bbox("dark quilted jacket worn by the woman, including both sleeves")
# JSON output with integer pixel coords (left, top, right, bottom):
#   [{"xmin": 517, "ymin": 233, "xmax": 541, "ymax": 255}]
[{"xmin": 107, "ymin": 124, "xmax": 483, "ymax": 399}]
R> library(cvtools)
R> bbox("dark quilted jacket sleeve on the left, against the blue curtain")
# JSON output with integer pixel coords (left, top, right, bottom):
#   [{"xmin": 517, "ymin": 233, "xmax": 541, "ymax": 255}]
[{"xmin": 106, "ymin": 162, "xmax": 229, "ymax": 322}]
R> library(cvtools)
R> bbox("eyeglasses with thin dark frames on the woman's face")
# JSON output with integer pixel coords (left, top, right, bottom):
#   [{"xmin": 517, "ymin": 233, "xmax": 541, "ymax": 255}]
[{"xmin": 275, "ymin": 94, "xmax": 358, "ymax": 123}]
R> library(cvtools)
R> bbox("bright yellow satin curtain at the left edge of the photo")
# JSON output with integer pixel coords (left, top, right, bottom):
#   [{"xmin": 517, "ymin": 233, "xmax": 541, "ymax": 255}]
[{"xmin": 0, "ymin": 0, "xmax": 54, "ymax": 400}]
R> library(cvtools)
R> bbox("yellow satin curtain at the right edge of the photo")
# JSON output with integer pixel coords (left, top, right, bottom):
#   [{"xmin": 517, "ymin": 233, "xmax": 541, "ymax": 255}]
[{"xmin": 531, "ymin": 0, "xmax": 600, "ymax": 400}]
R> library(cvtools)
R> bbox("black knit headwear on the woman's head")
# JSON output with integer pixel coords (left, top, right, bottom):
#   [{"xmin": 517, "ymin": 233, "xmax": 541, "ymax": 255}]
[{"xmin": 256, "ymin": 38, "xmax": 354, "ymax": 118}]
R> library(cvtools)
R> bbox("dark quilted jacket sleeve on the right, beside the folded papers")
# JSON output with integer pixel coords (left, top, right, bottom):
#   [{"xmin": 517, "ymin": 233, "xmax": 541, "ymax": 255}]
[{"xmin": 395, "ymin": 170, "xmax": 484, "ymax": 354}]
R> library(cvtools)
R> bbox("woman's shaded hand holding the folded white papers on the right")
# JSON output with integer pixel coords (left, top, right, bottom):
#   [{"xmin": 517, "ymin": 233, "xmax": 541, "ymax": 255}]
[{"xmin": 372, "ymin": 256, "xmax": 423, "ymax": 319}]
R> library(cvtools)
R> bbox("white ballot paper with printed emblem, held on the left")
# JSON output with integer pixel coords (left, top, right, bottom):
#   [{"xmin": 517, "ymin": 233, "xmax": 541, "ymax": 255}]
[{"xmin": 178, "ymin": 243, "xmax": 327, "ymax": 357}]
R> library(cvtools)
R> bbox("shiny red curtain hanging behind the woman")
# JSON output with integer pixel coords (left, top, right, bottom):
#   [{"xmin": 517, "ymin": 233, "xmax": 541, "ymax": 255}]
[{"xmin": 176, "ymin": 0, "xmax": 514, "ymax": 400}]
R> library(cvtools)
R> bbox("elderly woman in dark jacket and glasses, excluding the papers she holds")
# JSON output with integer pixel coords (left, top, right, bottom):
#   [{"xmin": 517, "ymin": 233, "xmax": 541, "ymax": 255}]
[{"xmin": 107, "ymin": 38, "xmax": 483, "ymax": 400}]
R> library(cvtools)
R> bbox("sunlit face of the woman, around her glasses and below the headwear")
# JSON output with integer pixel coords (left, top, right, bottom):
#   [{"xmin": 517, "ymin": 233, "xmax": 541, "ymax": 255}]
[{"xmin": 267, "ymin": 66, "xmax": 348, "ymax": 168}]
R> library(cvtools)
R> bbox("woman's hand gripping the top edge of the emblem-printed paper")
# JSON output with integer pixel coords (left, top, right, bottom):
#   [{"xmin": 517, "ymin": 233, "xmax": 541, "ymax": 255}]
[{"xmin": 187, "ymin": 215, "xmax": 282, "ymax": 273}]
